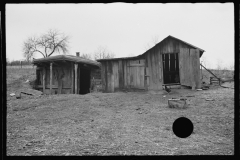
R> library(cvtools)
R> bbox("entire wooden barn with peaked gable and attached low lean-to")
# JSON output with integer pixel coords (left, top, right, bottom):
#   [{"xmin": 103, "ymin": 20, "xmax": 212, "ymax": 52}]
[{"xmin": 97, "ymin": 36, "xmax": 204, "ymax": 92}]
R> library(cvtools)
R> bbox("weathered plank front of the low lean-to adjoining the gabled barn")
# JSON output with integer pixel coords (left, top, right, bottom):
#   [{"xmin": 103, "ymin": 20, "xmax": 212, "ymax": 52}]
[{"xmin": 101, "ymin": 59, "xmax": 145, "ymax": 92}]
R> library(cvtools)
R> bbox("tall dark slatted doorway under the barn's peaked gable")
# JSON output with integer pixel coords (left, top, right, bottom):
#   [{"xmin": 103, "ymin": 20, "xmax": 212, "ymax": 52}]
[{"xmin": 162, "ymin": 53, "xmax": 180, "ymax": 84}]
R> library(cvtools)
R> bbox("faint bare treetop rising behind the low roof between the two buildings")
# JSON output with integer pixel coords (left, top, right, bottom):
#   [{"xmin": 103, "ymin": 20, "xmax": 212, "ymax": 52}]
[{"xmin": 94, "ymin": 46, "xmax": 115, "ymax": 60}]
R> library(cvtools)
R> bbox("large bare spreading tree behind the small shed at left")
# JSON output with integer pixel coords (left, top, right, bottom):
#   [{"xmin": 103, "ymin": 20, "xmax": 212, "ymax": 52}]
[{"xmin": 23, "ymin": 30, "xmax": 68, "ymax": 61}]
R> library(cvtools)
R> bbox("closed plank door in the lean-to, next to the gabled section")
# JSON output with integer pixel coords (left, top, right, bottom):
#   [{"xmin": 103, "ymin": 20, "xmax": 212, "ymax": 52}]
[{"xmin": 128, "ymin": 59, "xmax": 145, "ymax": 89}]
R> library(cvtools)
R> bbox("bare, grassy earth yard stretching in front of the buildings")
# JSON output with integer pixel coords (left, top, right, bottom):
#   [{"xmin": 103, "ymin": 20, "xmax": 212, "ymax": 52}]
[{"xmin": 7, "ymin": 66, "xmax": 234, "ymax": 155}]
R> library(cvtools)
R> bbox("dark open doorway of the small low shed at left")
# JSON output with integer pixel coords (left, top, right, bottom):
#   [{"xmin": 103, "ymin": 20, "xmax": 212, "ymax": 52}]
[{"xmin": 79, "ymin": 68, "xmax": 90, "ymax": 94}]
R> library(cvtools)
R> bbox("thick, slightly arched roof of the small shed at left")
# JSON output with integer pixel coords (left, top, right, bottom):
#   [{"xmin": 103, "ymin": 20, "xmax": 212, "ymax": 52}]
[{"xmin": 32, "ymin": 55, "xmax": 100, "ymax": 67}]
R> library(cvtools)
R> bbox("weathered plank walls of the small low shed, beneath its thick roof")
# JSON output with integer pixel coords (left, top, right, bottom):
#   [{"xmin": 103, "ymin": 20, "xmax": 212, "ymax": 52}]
[{"xmin": 37, "ymin": 62, "xmax": 101, "ymax": 94}]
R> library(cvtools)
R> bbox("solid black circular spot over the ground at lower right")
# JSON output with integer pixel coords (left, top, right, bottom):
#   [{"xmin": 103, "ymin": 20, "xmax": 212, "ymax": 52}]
[{"xmin": 172, "ymin": 117, "xmax": 193, "ymax": 138}]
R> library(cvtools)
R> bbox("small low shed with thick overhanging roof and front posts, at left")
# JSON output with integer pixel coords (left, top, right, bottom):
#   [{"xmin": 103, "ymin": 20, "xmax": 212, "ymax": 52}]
[{"xmin": 33, "ymin": 52, "xmax": 101, "ymax": 94}]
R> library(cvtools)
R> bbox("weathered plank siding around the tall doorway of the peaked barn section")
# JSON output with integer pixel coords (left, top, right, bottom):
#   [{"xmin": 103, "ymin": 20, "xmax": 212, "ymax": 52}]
[{"xmin": 145, "ymin": 38, "xmax": 200, "ymax": 90}]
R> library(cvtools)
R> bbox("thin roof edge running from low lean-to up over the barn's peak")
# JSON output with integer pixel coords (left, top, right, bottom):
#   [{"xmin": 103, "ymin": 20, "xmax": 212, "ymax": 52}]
[{"xmin": 97, "ymin": 35, "xmax": 205, "ymax": 62}]
